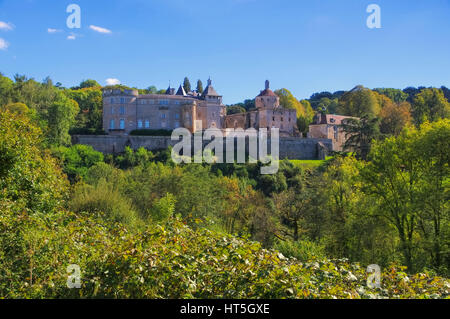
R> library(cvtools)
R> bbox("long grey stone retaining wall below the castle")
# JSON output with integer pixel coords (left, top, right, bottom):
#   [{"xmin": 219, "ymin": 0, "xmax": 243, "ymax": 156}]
[{"xmin": 72, "ymin": 135, "xmax": 333, "ymax": 159}]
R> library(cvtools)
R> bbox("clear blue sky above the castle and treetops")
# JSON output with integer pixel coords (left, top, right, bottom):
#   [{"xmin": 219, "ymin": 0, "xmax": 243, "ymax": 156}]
[{"xmin": 0, "ymin": 0, "xmax": 450, "ymax": 104}]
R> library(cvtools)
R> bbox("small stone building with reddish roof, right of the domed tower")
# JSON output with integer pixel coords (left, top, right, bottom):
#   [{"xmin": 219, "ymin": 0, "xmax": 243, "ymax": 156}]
[{"xmin": 308, "ymin": 113, "xmax": 353, "ymax": 151}]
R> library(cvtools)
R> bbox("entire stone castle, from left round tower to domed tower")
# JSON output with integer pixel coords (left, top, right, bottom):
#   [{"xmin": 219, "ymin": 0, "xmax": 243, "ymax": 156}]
[{"xmin": 103, "ymin": 79, "xmax": 299, "ymax": 137}]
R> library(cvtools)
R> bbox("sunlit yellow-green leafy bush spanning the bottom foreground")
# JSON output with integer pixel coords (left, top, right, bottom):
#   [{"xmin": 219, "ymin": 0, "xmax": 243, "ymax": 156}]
[{"xmin": 0, "ymin": 207, "xmax": 450, "ymax": 298}]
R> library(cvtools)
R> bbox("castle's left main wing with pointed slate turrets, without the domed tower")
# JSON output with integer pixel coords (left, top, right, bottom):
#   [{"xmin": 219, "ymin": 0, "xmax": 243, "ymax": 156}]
[{"xmin": 103, "ymin": 80, "xmax": 226, "ymax": 135}]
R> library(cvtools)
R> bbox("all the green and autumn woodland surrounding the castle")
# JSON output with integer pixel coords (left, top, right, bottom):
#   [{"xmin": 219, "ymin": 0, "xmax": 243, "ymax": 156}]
[{"xmin": 0, "ymin": 74, "xmax": 450, "ymax": 298}]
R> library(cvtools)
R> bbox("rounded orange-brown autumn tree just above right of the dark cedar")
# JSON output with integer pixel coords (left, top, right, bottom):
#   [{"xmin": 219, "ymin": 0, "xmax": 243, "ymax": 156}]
[{"xmin": 380, "ymin": 102, "xmax": 412, "ymax": 136}]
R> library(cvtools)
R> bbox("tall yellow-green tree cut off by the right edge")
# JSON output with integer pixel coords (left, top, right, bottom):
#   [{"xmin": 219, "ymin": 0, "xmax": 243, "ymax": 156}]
[{"xmin": 411, "ymin": 119, "xmax": 450, "ymax": 273}]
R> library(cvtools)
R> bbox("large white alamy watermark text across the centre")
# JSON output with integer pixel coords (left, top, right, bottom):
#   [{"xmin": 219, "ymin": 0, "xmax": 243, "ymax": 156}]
[{"xmin": 171, "ymin": 121, "xmax": 280, "ymax": 174}]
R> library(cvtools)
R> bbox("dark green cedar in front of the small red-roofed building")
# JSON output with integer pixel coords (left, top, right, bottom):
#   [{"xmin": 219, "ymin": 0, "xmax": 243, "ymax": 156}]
[{"xmin": 342, "ymin": 116, "xmax": 379, "ymax": 160}]
